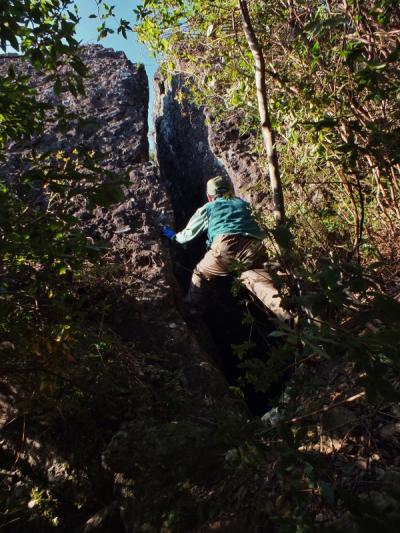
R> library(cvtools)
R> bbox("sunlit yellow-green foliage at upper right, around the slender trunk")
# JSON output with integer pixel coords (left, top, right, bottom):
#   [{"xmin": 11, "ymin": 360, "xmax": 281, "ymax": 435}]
[{"xmin": 136, "ymin": 0, "xmax": 399, "ymax": 259}]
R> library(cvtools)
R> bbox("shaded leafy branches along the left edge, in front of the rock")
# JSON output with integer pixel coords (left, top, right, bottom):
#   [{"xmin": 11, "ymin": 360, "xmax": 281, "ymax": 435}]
[{"xmin": 0, "ymin": 1, "xmax": 126, "ymax": 378}]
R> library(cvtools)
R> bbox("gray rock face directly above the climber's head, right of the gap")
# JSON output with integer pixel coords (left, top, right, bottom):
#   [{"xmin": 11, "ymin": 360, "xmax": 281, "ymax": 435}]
[{"xmin": 154, "ymin": 74, "xmax": 266, "ymax": 222}]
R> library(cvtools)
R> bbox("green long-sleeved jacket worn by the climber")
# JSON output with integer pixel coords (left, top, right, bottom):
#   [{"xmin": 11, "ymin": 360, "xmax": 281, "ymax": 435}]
[{"xmin": 175, "ymin": 197, "xmax": 263, "ymax": 247}]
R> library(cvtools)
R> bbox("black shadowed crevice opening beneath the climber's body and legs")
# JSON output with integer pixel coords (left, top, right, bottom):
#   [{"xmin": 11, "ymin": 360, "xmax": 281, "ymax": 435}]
[{"xmin": 173, "ymin": 239, "xmax": 287, "ymax": 415}]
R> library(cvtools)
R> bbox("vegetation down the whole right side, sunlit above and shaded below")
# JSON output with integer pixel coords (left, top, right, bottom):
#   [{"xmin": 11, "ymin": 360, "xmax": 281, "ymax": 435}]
[{"xmin": 136, "ymin": 0, "xmax": 400, "ymax": 531}]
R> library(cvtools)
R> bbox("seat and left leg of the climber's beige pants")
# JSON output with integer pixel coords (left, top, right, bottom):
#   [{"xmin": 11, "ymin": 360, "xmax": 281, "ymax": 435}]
[{"xmin": 185, "ymin": 235, "xmax": 265, "ymax": 307}]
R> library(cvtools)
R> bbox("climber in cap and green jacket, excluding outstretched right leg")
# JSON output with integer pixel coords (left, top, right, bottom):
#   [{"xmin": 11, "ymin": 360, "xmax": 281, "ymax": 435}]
[{"xmin": 162, "ymin": 176, "xmax": 265, "ymax": 313}]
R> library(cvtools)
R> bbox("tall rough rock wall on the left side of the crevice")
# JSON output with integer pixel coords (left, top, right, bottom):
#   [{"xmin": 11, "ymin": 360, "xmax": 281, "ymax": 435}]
[{"xmin": 0, "ymin": 46, "xmax": 237, "ymax": 532}]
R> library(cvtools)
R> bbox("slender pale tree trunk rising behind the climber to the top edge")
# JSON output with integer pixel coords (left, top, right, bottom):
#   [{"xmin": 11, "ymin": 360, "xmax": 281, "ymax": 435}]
[{"xmin": 238, "ymin": 0, "xmax": 285, "ymax": 224}]
